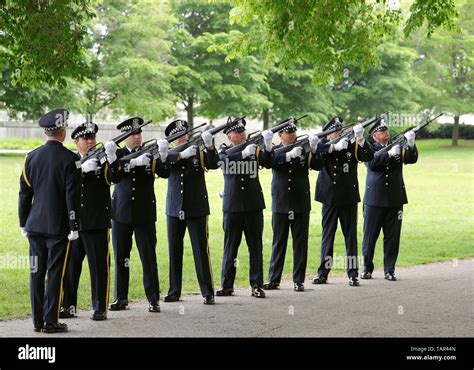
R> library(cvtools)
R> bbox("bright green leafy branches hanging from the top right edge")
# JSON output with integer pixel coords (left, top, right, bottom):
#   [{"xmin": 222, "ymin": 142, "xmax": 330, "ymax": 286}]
[{"xmin": 227, "ymin": 0, "xmax": 456, "ymax": 82}]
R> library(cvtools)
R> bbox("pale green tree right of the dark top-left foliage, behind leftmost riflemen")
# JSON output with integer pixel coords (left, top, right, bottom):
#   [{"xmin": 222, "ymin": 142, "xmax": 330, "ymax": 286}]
[{"xmin": 71, "ymin": 0, "xmax": 179, "ymax": 120}]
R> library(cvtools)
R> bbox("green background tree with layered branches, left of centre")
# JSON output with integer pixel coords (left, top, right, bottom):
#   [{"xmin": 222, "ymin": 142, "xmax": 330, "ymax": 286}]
[{"xmin": 171, "ymin": 1, "xmax": 269, "ymax": 126}]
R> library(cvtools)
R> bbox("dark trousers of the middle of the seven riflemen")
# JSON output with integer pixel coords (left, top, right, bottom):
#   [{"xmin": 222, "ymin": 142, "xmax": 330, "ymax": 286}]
[{"xmin": 221, "ymin": 210, "xmax": 263, "ymax": 289}]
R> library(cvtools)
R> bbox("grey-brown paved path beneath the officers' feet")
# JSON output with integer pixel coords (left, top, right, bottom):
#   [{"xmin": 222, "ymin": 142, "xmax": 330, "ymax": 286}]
[{"xmin": 0, "ymin": 259, "xmax": 474, "ymax": 337}]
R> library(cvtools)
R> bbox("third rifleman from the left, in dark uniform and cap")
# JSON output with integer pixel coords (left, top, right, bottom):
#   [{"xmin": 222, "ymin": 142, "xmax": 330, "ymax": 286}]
[{"xmin": 164, "ymin": 120, "xmax": 219, "ymax": 304}]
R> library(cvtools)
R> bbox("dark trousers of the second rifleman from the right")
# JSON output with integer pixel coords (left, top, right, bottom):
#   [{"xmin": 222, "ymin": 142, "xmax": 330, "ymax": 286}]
[{"xmin": 318, "ymin": 203, "xmax": 359, "ymax": 278}]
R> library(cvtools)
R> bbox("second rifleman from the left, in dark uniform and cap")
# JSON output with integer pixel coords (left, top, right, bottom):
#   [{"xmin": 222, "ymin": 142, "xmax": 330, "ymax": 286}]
[{"xmin": 109, "ymin": 117, "xmax": 169, "ymax": 312}]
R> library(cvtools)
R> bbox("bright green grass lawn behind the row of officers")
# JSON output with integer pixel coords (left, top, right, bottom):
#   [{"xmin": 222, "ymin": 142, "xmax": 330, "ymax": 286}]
[{"xmin": 0, "ymin": 139, "xmax": 474, "ymax": 319}]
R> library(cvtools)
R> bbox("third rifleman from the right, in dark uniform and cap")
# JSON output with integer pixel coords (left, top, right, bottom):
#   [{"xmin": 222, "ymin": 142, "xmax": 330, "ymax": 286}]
[{"xmin": 264, "ymin": 123, "xmax": 319, "ymax": 292}]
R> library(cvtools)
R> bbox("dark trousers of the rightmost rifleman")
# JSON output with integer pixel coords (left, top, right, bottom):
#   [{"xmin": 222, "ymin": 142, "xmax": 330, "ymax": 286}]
[{"xmin": 362, "ymin": 205, "xmax": 403, "ymax": 274}]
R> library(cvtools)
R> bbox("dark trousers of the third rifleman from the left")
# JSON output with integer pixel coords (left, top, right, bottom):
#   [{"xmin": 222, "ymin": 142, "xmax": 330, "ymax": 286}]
[{"xmin": 167, "ymin": 216, "xmax": 214, "ymax": 297}]
